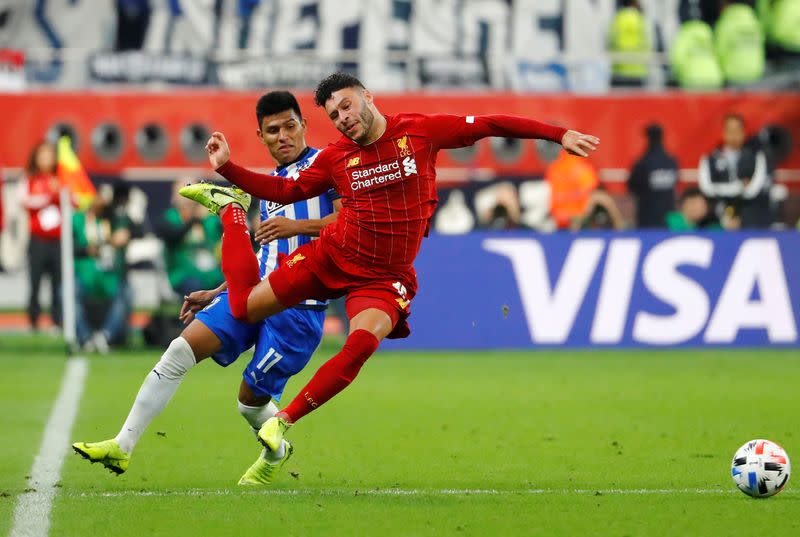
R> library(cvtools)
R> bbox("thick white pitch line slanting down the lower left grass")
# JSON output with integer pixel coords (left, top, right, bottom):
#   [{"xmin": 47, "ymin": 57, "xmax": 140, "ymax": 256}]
[{"xmin": 9, "ymin": 358, "xmax": 89, "ymax": 537}]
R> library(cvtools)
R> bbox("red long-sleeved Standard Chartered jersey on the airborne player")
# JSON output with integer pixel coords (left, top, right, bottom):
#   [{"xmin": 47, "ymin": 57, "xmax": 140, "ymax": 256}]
[{"xmin": 217, "ymin": 114, "xmax": 566, "ymax": 272}]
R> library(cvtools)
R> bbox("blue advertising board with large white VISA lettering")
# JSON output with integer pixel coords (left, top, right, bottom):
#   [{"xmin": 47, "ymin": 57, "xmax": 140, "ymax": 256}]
[{"xmin": 382, "ymin": 232, "xmax": 800, "ymax": 349}]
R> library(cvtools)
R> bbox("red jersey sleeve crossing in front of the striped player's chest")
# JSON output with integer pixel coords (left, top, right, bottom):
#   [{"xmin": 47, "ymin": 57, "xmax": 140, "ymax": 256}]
[{"xmin": 217, "ymin": 152, "xmax": 334, "ymax": 204}]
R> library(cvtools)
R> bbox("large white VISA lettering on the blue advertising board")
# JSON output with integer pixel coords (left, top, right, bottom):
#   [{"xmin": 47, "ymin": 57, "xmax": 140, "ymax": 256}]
[{"xmin": 483, "ymin": 236, "xmax": 797, "ymax": 345}]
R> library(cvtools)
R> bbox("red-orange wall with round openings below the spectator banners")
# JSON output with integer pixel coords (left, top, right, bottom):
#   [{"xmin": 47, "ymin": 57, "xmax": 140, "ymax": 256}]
[{"xmin": 0, "ymin": 90, "xmax": 800, "ymax": 186}]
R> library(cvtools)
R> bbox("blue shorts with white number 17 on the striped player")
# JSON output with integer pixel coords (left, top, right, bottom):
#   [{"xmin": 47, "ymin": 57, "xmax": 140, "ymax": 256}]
[{"xmin": 196, "ymin": 291, "xmax": 325, "ymax": 401}]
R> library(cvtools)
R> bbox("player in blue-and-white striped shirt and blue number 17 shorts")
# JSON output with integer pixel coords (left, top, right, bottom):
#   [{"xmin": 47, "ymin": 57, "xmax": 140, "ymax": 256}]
[{"xmin": 73, "ymin": 91, "xmax": 341, "ymax": 485}]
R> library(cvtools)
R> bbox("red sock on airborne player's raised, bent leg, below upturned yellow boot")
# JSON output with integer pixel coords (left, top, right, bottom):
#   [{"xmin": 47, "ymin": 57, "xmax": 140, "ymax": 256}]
[{"xmin": 219, "ymin": 204, "xmax": 261, "ymax": 321}]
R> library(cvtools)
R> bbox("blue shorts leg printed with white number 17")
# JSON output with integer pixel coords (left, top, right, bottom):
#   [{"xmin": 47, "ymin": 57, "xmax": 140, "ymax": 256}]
[{"xmin": 243, "ymin": 309, "xmax": 325, "ymax": 400}]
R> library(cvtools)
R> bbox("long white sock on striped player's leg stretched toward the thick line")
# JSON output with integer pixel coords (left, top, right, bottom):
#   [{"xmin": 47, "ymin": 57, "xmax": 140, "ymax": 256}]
[{"xmin": 115, "ymin": 337, "xmax": 195, "ymax": 453}]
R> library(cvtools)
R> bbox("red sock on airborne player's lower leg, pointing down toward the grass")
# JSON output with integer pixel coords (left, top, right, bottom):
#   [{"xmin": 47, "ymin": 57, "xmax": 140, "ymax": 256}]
[{"xmin": 280, "ymin": 330, "xmax": 380, "ymax": 423}]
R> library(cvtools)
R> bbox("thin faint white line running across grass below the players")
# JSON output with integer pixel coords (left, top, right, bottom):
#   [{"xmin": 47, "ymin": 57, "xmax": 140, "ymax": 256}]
[{"xmin": 67, "ymin": 486, "xmax": 786, "ymax": 498}]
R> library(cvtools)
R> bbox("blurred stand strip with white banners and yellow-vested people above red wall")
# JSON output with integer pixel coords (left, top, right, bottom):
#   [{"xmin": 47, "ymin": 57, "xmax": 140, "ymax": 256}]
[{"xmin": 0, "ymin": 0, "xmax": 800, "ymax": 92}]
